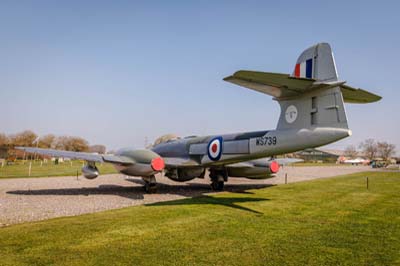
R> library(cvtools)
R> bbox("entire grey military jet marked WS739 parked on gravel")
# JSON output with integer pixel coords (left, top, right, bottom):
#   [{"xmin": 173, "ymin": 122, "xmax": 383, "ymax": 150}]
[{"xmin": 19, "ymin": 43, "xmax": 381, "ymax": 192}]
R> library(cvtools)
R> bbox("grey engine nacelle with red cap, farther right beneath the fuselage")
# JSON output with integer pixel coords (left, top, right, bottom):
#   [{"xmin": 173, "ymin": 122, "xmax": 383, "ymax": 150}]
[{"xmin": 226, "ymin": 159, "xmax": 279, "ymax": 179}]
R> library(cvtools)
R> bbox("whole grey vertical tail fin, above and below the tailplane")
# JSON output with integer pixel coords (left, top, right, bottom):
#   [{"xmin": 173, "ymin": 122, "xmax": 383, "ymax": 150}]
[{"xmin": 277, "ymin": 43, "xmax": 348, "ymax": 129}]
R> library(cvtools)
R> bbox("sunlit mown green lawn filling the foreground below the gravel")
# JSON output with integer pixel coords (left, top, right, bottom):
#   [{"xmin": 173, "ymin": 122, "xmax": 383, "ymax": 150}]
[{"xmin": 0, "ymin": 172, "xmax": 400, "ymax": 265}]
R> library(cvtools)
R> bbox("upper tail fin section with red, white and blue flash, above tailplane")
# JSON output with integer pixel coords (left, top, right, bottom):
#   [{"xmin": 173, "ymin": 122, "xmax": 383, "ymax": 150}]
[{"xmin": 293, "ymin": 43, "xmax": 338, "ymax": 81}]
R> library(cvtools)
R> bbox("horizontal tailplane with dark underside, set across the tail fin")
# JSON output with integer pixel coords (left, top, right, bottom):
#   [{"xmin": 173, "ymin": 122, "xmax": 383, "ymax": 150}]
[{"xmin": 224, "ymin": 70, "xmax": 382, "ymax": 103}]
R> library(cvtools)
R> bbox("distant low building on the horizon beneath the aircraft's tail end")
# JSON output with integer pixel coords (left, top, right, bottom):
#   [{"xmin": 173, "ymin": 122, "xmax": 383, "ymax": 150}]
[{"xmin": 295, "ymin": 149, "xmax": 343, "ymax": 163}]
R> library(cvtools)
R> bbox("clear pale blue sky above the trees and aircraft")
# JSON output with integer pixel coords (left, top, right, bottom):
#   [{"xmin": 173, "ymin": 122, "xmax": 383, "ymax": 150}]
[{"xmin": 0, "ymin": 1, "xmax": 400, "ymax": 153}]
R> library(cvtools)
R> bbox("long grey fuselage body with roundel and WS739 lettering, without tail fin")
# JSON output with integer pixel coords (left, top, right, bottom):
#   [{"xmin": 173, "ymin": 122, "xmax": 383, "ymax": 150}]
[{"xmin": 152, "ymin": 128, "xmax": 351, "ymax": 167}]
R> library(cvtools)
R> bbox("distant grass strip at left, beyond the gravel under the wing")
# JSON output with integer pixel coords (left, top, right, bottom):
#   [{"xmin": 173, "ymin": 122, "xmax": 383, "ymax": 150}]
[{"xmin": 0, "ymin": 161, "xmax": 117, "ymax": 179}]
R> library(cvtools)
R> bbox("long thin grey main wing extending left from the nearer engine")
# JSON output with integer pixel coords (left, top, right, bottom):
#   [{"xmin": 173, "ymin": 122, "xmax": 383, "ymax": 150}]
[{"xmin": 15, "ymin": 147, "xmax": 135, "ymax": 164}]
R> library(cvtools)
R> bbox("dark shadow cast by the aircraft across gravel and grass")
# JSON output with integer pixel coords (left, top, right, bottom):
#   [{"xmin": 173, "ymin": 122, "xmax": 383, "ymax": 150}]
[{"xmin": 7, "ymin": 179, "xmax": 272, "ymax": 213}]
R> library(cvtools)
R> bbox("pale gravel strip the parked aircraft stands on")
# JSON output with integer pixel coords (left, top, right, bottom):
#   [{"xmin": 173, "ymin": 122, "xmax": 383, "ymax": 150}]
[{"xmin": 0, "ymin": 166, "xmax": 371, "ymax": 227}]
